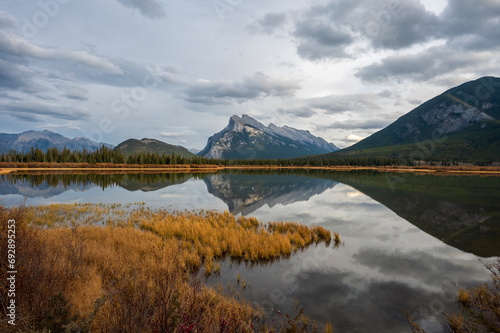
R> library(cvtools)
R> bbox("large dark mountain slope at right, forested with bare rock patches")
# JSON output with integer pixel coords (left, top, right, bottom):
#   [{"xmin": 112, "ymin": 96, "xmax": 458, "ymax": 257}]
[{"xmin": 336, "ymin": 77, "xmax": 500, "ymax": 161}]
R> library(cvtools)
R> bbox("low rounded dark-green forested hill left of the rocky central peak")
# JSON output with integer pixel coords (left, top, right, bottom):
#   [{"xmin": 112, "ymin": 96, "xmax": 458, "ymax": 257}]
[{"xmin": 115, "ymin": 138, "xmax": 196, "ymax": 157}]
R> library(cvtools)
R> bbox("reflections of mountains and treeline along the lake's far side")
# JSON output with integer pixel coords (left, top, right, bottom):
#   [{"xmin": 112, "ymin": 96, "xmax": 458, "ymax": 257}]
[{"xmin": 0, "ymin": 171, "xmax": 500, "ymax": 257}]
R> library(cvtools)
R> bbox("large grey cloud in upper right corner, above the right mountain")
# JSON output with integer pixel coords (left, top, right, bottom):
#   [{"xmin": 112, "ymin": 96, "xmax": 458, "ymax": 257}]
[{"xmin": 356, "ymin": 0, "xmax": 500, "ymax": 83}]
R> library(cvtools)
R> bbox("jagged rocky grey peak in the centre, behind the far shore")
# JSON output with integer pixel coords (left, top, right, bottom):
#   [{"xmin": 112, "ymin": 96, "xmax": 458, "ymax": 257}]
[{"xmin": 198, "ymin": 115, "xmax": 338, "ymax": 159}]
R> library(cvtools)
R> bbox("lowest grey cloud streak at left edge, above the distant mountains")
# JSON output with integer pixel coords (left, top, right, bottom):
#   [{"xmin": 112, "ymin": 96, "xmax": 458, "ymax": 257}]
[{"xmin": 0, "ymin": 101, "xmax": 89, "ymax": 122}]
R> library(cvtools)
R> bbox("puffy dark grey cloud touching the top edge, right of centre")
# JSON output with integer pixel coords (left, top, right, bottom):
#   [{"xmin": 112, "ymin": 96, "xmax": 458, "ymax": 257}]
[{"xmin": 293, "ymin": 0, "xmax": 439, "ymax": 60}]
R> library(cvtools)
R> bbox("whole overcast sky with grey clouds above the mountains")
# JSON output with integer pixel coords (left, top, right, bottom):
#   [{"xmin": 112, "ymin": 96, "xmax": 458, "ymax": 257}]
[{"xmin": 0, "ymin": 0, "xmax": 500, "ymax": 149}]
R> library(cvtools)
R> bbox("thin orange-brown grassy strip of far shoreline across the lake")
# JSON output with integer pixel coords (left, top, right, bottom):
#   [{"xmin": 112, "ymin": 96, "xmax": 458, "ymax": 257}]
[{"xmin": 0, "ymin": 165, "xmax": 500, "ymax": 176}]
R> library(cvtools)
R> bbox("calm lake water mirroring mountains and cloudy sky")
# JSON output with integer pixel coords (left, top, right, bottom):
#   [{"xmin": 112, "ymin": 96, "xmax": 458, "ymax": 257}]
[{"xmin": 0, "ymin": 171, "xmax": 500, "ymax": 332}]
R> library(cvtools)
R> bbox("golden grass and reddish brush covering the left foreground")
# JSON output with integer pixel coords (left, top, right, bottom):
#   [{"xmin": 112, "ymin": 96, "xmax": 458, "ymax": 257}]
[{"xmin": 0, "ymin": 204, "xmax": 332, "ymax": 332}]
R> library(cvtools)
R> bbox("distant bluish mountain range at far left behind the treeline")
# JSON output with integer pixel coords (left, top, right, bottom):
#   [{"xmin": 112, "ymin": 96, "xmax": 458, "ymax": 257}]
[{"xmin": 0, "ymin": 130, "xmax": 113, "ymax": 153}]
